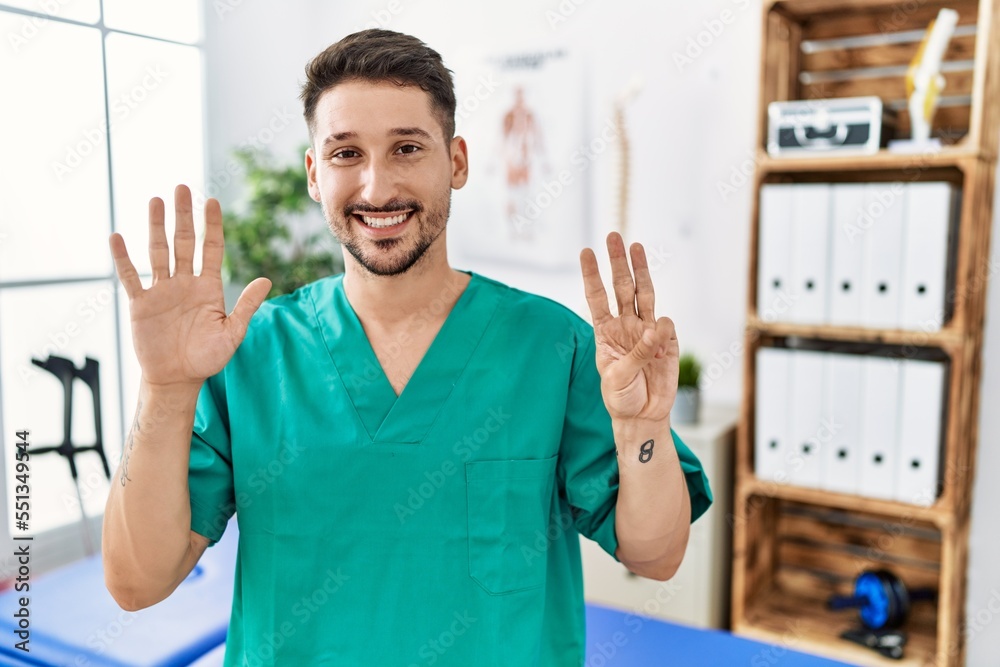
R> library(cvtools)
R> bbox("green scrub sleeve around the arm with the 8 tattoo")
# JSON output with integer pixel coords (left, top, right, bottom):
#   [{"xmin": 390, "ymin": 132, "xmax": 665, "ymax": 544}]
[{"xmin": 557, "ymin": 327, "xmax": 712, "ymax": 560}]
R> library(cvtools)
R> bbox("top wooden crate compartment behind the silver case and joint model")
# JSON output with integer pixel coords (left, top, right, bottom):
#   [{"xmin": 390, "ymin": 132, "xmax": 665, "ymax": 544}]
[{"xmin": 760, "ymin": 0, "xmax": 1000, "ymax": 151}]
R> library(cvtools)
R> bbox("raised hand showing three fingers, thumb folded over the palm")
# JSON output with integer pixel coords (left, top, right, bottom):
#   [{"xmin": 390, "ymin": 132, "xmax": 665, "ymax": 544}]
[{"xmin": 580, "ymin": 232, "xmax": 680, "ymax": 421}]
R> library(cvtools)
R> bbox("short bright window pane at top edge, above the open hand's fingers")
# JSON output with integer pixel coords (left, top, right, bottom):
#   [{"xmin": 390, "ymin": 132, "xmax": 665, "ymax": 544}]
[{"xmin": 104, "ymin": 0, "xmax": 201, "ymax": 43}]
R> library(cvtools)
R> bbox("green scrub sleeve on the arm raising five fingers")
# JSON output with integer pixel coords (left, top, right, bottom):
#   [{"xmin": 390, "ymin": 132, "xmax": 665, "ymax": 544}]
[{"xmin": 188, "ymin": 371, "xmax": 236, "ymax": 546}]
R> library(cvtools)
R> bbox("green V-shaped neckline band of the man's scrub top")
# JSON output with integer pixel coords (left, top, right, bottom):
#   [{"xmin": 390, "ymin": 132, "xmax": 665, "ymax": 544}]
[{"xmin": 311, "ymin": 271, "xmax": 501, "ymax": 444}]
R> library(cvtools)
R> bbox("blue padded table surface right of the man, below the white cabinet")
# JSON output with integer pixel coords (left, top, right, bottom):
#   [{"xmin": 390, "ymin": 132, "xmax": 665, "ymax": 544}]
[{"xmin": 585, "ymin": 604, "xmax": 860, "ymax": 667}]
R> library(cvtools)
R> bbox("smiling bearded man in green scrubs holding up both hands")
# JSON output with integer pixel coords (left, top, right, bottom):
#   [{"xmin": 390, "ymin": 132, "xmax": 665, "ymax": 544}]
[{"xmin": 103, "ymin": 30, "xmax": 711, "ymax": 667}]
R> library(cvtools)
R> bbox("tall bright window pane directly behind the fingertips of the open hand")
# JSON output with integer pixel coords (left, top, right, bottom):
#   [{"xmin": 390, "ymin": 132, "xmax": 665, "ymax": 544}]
[{"xmin": 107, "ymin": 34, "xmax": 205, "ymax": 273}]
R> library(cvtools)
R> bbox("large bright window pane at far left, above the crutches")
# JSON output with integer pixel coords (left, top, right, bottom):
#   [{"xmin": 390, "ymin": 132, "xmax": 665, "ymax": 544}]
[{"xmin": 0, "ymin": 12, "xmax": 112, "ymax": 281}]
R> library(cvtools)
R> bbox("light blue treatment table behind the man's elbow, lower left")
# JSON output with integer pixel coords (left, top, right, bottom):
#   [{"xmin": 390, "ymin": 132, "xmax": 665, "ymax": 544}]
[{"xmin": 0, "ymin": 520, "xmax": 239, "ymax": 667}]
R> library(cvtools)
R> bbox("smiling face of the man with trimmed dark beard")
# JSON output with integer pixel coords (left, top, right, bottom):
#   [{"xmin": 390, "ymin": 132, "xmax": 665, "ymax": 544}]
[{"xmin": 305, "ymin": 81, "xmax": 468, "ymax": 275}]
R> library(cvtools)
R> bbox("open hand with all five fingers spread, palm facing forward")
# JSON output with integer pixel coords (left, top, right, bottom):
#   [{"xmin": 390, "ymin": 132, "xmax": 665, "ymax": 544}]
[{"xmin": 109, "ymin": 185, "xmax": 271, "ymax": 386}]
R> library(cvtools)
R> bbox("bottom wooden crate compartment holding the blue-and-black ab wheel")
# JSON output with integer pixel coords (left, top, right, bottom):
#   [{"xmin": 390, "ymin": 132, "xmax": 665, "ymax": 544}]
[{"xmin": 733, "ymin": 496, "xmax": 951, "ymax": 665}]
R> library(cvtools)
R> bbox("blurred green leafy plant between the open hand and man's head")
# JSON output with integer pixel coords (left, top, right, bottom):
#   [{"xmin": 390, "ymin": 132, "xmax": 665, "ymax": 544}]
[{"xmin": 223, "ymin": 147, "xmax": 344, "ymax": 298}]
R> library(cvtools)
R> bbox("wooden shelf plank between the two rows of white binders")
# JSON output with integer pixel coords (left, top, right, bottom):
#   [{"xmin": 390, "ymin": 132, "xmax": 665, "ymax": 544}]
[{"xmin": 746, "ymin": 316, "xmax": 966, "ymax": 352}]
